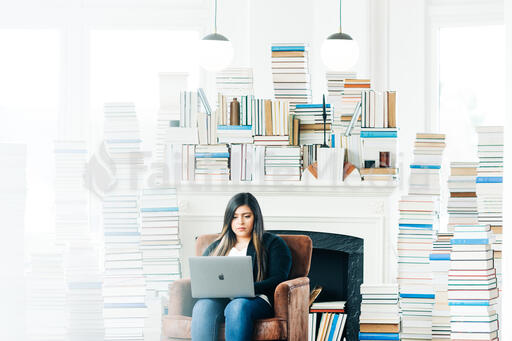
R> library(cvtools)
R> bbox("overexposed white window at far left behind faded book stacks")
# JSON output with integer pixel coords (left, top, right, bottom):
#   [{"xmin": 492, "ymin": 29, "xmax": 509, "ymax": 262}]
[{"xmin": 0, "ymin": 29, "xmax": 61, "ymax": 236}]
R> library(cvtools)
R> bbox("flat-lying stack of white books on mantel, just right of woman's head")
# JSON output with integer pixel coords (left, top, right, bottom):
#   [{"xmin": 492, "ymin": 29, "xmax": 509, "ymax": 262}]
[{"xmin": 265, "ymin": 146, "xmax": 301, "ymax": 181}]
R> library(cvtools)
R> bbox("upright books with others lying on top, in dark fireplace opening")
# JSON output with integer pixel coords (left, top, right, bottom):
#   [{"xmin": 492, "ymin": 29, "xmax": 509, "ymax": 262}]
[{"xmin": 308, "ymin": 301, "xmax": 347, "ymax": 341}]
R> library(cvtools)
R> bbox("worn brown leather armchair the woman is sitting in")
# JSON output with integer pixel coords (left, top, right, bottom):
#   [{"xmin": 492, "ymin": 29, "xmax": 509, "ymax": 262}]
[{"xmin": 162, "ymin": 234, "xmax": 313, "ymax": 341}]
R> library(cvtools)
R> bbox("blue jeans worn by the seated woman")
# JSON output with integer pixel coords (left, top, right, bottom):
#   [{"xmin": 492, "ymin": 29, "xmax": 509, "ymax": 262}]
[{"xmin": 192, "ymin": 297, "xmax": 274, "ymax": 341}]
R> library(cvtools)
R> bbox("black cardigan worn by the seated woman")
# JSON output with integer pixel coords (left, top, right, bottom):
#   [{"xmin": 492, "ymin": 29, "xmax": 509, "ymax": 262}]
[{"xmin": 203, "ymin": 232, "xmax": 292, "ymax": 306}]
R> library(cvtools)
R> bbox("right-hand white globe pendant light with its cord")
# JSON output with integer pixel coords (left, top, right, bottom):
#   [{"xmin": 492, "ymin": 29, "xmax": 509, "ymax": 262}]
[{"xmin": 321, "ymin": 0, "xmax": 359, "ymax": 71}]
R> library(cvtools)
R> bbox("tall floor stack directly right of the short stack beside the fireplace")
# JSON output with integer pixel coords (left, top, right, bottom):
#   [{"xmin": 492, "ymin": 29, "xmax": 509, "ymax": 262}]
[{"xmin": 398, "ymin": 196, "xmax": 439, "ymax": 340}]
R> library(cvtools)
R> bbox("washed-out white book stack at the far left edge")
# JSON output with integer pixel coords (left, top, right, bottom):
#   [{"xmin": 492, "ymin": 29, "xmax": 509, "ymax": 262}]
[{"xmin": 0, "ymin": 143, "xmax": 26, "ymax": 340}]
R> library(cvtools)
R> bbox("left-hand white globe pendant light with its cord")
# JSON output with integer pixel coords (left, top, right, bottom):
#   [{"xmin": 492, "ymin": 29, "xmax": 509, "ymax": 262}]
[{"xmin": 199, "ymin": 0, "xmax": 233, "ymax": 71}]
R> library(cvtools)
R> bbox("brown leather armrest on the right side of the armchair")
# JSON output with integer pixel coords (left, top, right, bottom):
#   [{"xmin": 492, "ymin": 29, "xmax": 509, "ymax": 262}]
[{"xmin": 274, "ymin": 277, "xmax": 309, "ymax": 341}]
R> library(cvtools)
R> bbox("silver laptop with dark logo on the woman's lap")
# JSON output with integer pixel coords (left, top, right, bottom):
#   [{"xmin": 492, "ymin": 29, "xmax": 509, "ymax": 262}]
[{"xmin": 189, "ymin": 256, "xmax": 254, "ymax": 298}]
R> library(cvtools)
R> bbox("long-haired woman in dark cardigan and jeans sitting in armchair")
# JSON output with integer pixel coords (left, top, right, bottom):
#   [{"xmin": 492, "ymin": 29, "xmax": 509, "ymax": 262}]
[{"xmin": 192, "ymin": 193, "xmax": 292, "ymax": 341}]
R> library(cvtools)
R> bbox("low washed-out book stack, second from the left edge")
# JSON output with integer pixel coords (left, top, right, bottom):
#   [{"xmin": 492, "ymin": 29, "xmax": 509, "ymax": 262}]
[{"xmin": 26, "ymin": 240, "xmax": 69, "ymax": 341}]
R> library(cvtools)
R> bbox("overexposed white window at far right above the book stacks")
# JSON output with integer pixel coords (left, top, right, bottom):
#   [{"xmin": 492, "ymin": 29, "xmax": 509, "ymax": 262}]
[{"xmin": 439, "ymin": 25, "xmax": 506, "ymax": 161}]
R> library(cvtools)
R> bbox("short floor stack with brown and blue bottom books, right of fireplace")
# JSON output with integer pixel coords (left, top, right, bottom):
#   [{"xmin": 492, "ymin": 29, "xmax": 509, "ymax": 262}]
[{"xmin": 359, "ymin": 284, "xmax": 400, "ymax": 340}]
